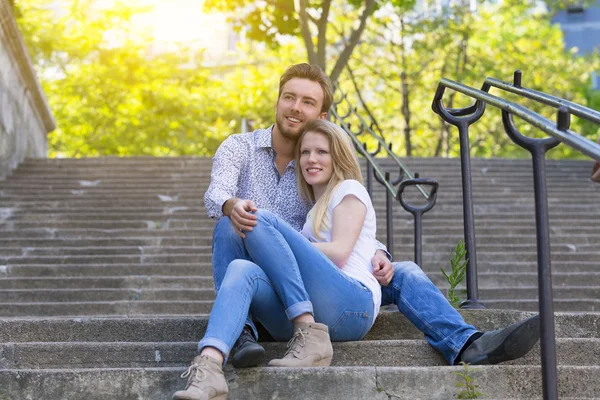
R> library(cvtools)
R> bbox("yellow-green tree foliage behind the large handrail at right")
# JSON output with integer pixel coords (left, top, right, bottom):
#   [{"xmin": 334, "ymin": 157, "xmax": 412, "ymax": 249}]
[{"xmin": 342, "ymin": 1, "xmax": 600, "ymax": 157}]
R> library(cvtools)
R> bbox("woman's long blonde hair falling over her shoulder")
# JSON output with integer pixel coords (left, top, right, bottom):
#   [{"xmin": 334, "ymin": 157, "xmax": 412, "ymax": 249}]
[{"xmin": 295, "ymin": 119, "xmax": 363, "ymax": 239}]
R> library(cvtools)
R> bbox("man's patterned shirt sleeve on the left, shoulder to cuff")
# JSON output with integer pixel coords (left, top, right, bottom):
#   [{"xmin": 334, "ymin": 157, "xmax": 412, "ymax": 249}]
[{"xmin": 204, "ymin": 136, "xmax": 246, "ymax": 219}]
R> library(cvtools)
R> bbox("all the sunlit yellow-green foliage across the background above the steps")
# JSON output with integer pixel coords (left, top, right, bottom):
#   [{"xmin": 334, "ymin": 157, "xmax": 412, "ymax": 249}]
[{"xmin": 14, "ymin": 0, "xmax": 600, "ymax": 157}]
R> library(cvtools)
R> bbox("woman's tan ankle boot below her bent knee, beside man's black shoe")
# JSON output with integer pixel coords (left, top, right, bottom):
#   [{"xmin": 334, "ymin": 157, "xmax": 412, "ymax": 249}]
[{"xmin": 269, "ymin": 322, "xmax": 333, "ymax": 367}]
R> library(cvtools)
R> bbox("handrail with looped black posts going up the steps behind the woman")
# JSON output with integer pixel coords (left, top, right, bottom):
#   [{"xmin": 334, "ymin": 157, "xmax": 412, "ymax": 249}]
[{"xmin": 329, "ymin": 86, "xmax": 438, "ymax": 266}]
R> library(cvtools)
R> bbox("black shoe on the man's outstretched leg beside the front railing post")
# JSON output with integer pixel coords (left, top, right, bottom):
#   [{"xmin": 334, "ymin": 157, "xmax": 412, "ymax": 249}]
[{"xmin": 459, "ymin": 315, "xmax": 540, "ymax": 365}]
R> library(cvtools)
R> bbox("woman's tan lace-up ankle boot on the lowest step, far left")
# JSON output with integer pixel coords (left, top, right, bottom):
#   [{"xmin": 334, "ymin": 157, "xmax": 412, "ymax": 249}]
[{"xmin": 173, "ymin": 356, "xmax": 229, "ymax": 400}]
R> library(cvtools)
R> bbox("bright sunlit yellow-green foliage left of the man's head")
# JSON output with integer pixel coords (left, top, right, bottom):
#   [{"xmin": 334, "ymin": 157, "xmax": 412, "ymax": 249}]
[{"xmin": 15, "ymin": 0, "xmax": 293, "ymax": 157}]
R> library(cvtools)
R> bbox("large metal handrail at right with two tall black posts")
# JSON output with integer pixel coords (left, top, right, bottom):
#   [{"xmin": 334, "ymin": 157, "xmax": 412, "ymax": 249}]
[{"xmin": 432, "ymin": 71, "xmax": 600, "ymax": 400}]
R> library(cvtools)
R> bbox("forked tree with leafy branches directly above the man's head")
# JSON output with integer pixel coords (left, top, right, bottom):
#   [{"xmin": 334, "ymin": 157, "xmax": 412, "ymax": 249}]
[{"xmin": 204, "ymin": 0, "xmax": 415, "ymax": 81}]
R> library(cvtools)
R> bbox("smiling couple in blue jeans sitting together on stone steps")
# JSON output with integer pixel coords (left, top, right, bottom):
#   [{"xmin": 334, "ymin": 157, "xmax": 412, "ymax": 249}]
[{"xmin": 173, "ymin": 64, "xmax": 539, "ymax": 400}]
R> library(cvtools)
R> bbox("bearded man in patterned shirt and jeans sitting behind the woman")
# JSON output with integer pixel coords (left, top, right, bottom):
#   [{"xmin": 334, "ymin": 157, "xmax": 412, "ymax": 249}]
[{"xmin": 205, "ymin": 64, "xmax": 539, "ymax": 368}]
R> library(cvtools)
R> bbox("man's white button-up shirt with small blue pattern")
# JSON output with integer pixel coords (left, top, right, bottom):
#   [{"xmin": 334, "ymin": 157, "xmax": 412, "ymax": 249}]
[{"xmin": 204, "ymin": 126, "xmax": 312, "ymax": 231}]
